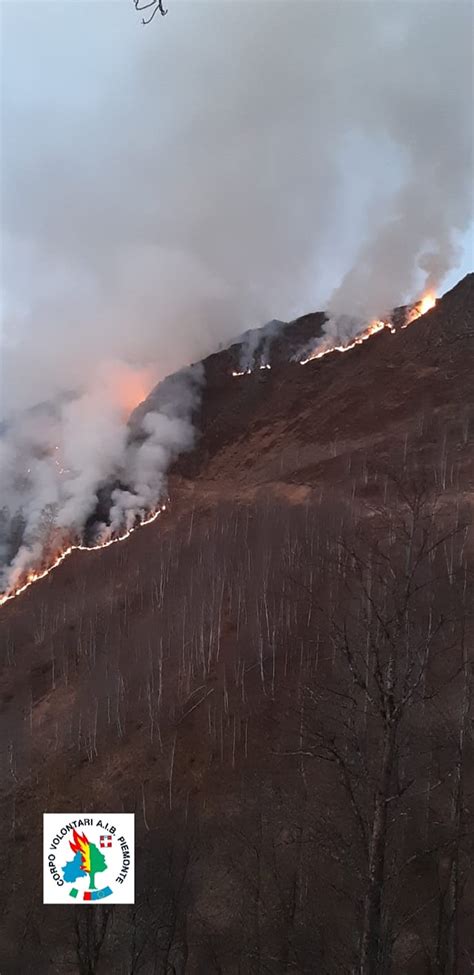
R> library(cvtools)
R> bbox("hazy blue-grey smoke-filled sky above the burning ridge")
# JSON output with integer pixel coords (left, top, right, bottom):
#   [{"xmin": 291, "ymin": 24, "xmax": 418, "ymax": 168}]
[{"xmin": 1, "ymin": 0, "xmax": 473, "ymax": 588}]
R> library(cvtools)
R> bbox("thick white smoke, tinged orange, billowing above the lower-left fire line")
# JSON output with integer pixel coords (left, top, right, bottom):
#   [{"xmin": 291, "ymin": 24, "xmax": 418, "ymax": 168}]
[{"xmin": 0, "ymin": 364, "xmax": 203, "ymax": 591}]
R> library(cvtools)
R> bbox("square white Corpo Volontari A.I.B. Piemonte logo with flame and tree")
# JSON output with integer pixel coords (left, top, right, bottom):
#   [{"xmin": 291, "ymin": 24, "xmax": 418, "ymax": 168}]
[{"xmin": 43, "ymin": 813, "xmax": 135, "ymax": 904}]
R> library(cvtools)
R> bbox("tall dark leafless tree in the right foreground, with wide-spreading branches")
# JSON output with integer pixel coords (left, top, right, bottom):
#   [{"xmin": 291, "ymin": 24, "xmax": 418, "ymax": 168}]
[{"xmin": 284, "ymin": 486, "xmax": 470, "ymax": 975}]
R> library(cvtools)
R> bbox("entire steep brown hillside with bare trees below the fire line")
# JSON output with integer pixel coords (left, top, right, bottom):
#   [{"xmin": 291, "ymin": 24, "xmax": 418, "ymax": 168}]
[{"xmin": 0, "ymin": 275, "xmax": 474, "ymax": 975}]
